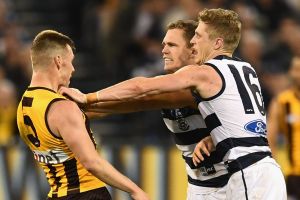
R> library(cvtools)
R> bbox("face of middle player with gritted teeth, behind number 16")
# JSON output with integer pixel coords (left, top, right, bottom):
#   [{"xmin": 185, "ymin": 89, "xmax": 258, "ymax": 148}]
[{"xmin": 162, "ymin": 29, "xmax": 194, "ymax": 73}]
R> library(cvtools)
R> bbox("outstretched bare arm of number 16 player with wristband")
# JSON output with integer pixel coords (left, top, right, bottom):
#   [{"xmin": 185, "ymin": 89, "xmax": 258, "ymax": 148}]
[{"xmin": 87, "ymin": 65, "xmax": 222, "ymax": 103}]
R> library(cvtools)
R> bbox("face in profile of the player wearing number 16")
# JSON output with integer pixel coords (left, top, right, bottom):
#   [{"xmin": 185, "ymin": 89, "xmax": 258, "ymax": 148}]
[{"xmin": 191, "ymin": 21, "xmax": 214, "ymax": 64}]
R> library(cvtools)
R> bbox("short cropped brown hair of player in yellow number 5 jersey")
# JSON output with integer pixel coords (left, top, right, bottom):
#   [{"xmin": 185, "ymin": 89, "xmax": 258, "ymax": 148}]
[{"xmin": 31, "ymin": 30, "xmax": 75, "ymax": 66}]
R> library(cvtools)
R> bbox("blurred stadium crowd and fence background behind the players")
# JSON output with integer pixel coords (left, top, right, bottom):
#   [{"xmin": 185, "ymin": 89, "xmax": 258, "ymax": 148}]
[{"xmin": 0, "ymin": 0, "xmax": 300, "ymax": 200}]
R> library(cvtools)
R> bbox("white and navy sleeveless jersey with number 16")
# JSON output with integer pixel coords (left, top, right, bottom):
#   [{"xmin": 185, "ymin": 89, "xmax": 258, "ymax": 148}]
[{"xmin": 194, "ymin": 56, "xmax": 271, "ymax": 173}]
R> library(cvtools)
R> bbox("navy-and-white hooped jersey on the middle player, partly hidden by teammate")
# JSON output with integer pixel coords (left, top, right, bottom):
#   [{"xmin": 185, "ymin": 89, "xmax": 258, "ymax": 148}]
[{"xmin": 162, "ymin": 107, "xmax": 229, "ymax": 187}]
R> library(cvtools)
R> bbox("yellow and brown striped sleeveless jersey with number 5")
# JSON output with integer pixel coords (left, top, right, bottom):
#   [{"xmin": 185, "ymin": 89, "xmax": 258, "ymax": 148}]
[{"xmin": 17, "ymin": 87, "xmax": 105, "ymax": 197}]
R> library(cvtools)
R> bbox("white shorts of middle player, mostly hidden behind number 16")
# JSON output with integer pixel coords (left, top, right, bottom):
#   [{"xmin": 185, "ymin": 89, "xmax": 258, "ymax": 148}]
[{"xmin": 187, "ymin": 184, "xmax": 226, "ymax": 200}]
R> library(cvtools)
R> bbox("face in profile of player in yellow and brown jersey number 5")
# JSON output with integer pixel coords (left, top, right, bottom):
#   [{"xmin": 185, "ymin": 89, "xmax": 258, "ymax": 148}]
[{"xmin": 60, "ymin": 45, "xmax": 75, "ymax": 87}]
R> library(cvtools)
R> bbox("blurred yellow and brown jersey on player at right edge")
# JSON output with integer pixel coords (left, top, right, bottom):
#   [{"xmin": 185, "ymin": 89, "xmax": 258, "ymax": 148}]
[{"xmin": 277, "ymin": 89, "xmax": 300, "ymax": 176}]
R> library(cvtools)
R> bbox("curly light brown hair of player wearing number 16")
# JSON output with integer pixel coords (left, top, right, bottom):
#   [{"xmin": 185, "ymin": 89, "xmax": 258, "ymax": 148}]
[{"xmin": 198, "ymin": 8, "xmax": 241, "ymax": 52}]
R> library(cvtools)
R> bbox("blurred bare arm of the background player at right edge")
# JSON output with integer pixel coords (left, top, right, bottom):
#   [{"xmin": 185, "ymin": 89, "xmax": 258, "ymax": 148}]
[{"xmin": 267, "ymin": 98, "xmax": 280, "ymax": 158}]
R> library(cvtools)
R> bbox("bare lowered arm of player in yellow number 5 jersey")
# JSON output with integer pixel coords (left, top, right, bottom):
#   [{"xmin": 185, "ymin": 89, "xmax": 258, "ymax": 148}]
[{"xmin": 47, "ymin": 100, "xmax": 148, "ymax": 199}]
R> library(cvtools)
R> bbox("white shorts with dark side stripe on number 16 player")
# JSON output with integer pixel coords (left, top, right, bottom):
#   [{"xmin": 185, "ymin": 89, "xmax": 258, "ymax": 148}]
[{"xmin": 226, "ymin": 157, "xmax": 287, "ymax": 200}]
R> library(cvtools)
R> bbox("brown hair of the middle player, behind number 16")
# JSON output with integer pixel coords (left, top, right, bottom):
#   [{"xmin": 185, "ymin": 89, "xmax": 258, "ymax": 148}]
[{"xmin": 167, "ymin": 20, "xmax": 198, "ymax": 47}]
